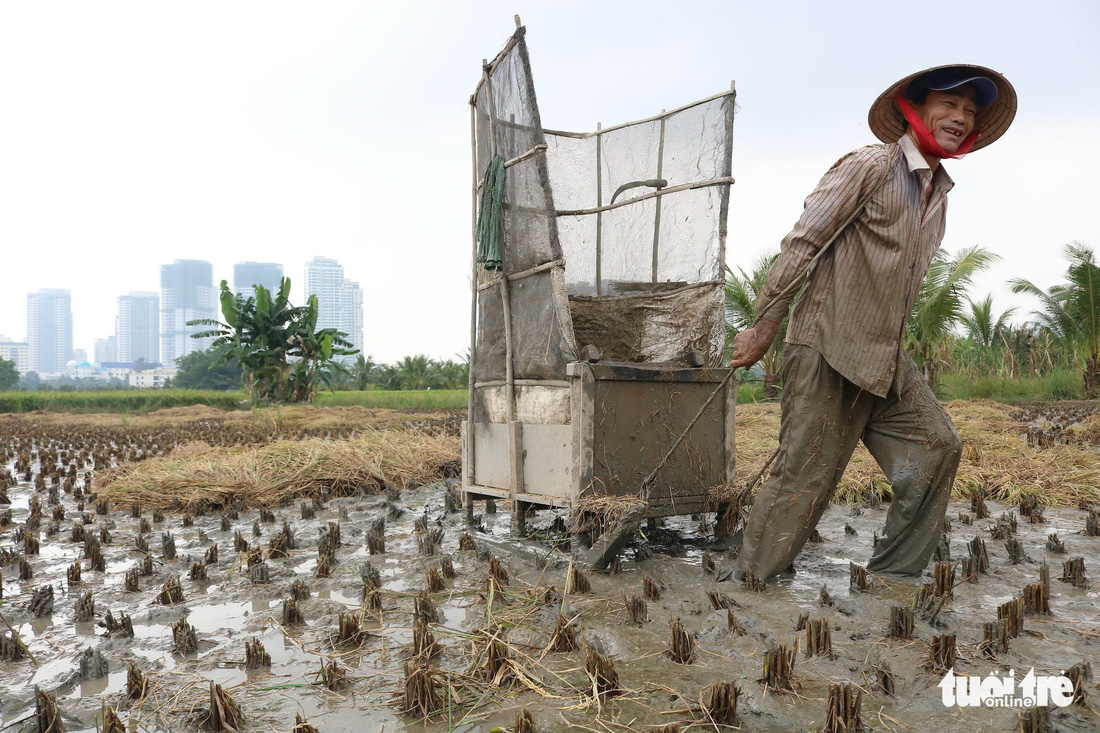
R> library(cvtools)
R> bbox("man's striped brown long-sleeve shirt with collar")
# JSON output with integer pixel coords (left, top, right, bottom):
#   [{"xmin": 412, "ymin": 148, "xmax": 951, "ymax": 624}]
[{"xmin": 757, "ymin": 135, "xmax": 954, "ymax": 396}]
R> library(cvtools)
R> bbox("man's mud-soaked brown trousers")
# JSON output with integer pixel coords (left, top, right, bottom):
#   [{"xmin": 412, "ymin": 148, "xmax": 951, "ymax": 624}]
[{"xmin": 737, "ymin": 343, "xmax": 963, "ymax": 578}]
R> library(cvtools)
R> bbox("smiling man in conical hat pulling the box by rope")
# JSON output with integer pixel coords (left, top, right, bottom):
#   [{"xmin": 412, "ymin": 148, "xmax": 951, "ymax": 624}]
[{"xmin": 725, "ymin": 65, "xmax": 1016, "ymax": 578}]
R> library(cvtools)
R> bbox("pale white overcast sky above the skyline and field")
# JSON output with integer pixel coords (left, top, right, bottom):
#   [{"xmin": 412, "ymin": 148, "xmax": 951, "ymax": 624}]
[{"xmin": 0, "ymin": 0, "xmax": 1100, "ymax": 361}]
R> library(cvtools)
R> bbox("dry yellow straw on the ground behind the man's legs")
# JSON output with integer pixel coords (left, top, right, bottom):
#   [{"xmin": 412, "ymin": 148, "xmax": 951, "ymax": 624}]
[{"xmin": 737, "ymin": 400, "xmax": 1100, "ymax": 506}]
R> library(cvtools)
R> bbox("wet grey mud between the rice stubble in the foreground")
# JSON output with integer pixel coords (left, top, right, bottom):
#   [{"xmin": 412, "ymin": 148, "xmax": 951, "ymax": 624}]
[{"xmin": 0, "ymin": 407, "xmax": 1100, "ymax": 732}]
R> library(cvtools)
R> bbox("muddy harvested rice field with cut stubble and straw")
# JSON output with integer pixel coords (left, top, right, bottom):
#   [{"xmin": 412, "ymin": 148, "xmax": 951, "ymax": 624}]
[{"xmin": 0, "ymin": 405, "xmax": 1100, "ymax": 733}]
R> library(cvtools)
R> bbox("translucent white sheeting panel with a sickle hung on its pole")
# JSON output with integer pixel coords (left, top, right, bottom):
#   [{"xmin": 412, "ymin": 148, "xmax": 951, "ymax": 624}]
[{"xmin": 546, "ymin": 90, "xmax": 734, "ymax": 297}]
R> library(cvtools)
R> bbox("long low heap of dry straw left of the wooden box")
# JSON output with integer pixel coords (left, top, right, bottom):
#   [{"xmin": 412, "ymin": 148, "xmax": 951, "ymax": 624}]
[{"xmin": 97, "ymin": 429, "xmax": 459, "ymax": 510}]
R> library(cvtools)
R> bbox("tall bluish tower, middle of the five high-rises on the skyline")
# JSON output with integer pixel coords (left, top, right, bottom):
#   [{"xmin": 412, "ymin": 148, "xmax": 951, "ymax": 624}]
[{"xmin": 159, "ymin": 260, "xmax": 218, "ymax": 367}]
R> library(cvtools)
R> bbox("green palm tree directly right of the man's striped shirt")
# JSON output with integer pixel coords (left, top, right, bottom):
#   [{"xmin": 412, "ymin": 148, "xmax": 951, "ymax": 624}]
[{"xmin": 905, "ymin": 244, "xmax": 1000, "ymax": 386}]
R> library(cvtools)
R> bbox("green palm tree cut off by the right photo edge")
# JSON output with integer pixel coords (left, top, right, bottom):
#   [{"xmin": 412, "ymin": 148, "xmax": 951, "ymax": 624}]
[{"xmin": 1010, "ymin": 242, "xmax": 1100, "ymax": 395}]
